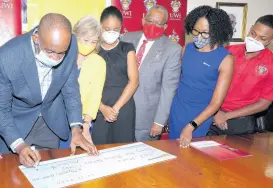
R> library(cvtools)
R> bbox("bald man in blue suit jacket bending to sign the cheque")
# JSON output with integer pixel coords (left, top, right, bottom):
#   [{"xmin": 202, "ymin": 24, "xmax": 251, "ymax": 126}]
[{"xmin": 0, "ymin": 13, "xmax": 97, "ymax": 167}]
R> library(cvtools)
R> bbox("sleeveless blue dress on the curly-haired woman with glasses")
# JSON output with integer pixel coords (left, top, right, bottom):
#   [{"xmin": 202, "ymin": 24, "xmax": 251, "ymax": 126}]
[{"xmin": 169, "ymin": 43, "xmax": 229, "ymax": 139}]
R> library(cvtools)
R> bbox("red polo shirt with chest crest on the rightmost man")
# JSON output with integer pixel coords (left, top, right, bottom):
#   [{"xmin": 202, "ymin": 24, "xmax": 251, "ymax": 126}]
[{"xmin": 222, "ymin": 44, "xmax": 273, "ymax": 111}]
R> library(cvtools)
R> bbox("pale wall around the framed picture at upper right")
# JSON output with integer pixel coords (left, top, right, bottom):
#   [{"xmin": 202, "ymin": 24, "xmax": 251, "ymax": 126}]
[{"xmin": 186, "ymin": 0, "xmax": 273, "ymax": 49}]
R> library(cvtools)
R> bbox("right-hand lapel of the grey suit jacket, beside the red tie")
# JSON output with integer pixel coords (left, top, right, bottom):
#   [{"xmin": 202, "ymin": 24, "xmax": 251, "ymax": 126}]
[{"xmin": 139, "ymin": 36, "xmax": 165, "ymax": 70}]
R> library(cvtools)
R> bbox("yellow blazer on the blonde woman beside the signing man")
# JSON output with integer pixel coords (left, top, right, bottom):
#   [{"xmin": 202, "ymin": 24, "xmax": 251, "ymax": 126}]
[{"xmin": 78, "ymin": 53, "xmax": 106, "ymax": 119}]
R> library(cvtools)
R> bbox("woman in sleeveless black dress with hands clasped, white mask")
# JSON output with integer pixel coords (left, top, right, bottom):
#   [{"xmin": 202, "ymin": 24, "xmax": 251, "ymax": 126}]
[{"xmin": 92, "ymin": 6, "xmax": 138, "ymax": 144}]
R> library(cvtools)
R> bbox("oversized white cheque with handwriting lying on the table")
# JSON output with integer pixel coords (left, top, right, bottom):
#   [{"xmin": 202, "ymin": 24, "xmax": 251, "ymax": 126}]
[{"xmin": 20, "ymin": 143, "xmax": 176, "ymax": 188}]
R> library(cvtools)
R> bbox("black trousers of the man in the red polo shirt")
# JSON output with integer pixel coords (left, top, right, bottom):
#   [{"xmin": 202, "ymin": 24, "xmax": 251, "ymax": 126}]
[{"xmin": 207, "ymin": 116, "xmax": 256, "ymax": 136}]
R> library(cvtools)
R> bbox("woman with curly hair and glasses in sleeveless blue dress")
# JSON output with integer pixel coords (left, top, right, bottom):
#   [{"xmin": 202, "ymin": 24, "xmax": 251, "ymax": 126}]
[{"xmin": 169, "ymin": 6, "xmax": 234, "ymax": 147}]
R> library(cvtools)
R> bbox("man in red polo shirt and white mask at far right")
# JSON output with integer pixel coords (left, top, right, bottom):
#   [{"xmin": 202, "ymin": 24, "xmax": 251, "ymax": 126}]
[{"xmin": 208, "ymin": 15, "xmax": 273, "ymax": 136}]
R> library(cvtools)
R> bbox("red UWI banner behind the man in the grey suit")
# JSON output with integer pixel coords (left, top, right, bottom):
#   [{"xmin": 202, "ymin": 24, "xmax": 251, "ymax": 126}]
[{"xmin": 112, "ymin": 0, "xmax": 187, "ymax": 45}]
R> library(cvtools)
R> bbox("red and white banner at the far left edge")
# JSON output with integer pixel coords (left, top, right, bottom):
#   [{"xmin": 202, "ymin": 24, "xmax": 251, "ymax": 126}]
[{"xmin": 0, "ymin": 0, "xmax": 22, "ymax": 46}]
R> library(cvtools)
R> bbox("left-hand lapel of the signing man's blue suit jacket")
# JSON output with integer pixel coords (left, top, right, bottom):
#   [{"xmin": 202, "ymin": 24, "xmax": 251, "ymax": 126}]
[{"xmin": 21, "ymin": 35, "xmax": 42, "ymax": 102}]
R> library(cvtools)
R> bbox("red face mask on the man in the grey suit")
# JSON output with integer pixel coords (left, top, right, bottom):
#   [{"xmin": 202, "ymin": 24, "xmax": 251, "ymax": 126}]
[{"xmin": 143, "ymin": 24, "xmax": 164, "ymax": 40}]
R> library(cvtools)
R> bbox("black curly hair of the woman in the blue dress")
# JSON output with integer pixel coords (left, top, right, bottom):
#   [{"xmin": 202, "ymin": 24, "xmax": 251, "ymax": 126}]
[{"xmin": 184, "ymin": 6, "xmax": 233, "ymax": 48}]
